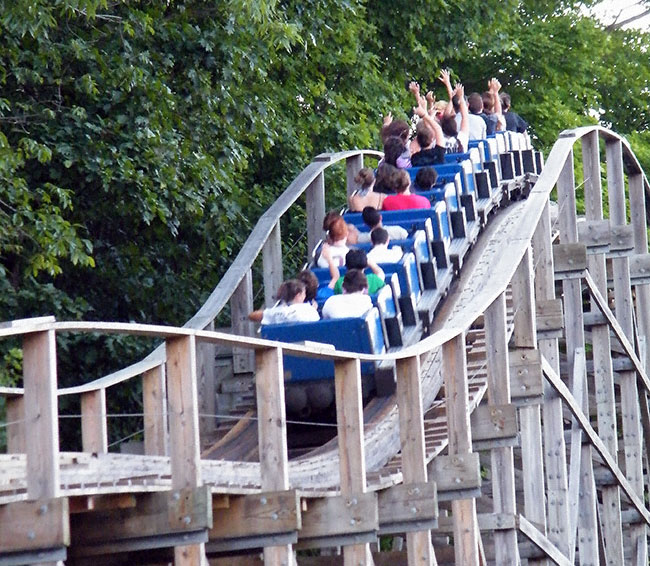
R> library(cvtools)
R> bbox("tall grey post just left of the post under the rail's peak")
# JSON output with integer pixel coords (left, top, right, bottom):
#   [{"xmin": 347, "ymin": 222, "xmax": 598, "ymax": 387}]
[{"xmin": 557, "ymin": 152, "xmax": 599, "ymax": 564}]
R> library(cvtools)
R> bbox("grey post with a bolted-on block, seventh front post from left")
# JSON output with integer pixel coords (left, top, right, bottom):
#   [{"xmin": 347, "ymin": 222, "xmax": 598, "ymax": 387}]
[{"xmin": 484, "ymin": 293, "xmax": 520, "ymax": 566}]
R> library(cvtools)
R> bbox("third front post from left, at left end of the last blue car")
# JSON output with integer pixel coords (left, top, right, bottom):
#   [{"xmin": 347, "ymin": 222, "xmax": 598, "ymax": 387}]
[{"xmin": 255, "ymin": 348, "xmax": 294, "ymax": 566}]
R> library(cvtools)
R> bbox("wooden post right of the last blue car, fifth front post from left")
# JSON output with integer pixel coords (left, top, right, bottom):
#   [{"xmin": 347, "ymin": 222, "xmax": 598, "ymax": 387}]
[{"xmin": 396, "ymin": 356, "xmax": 436, "ymax": 566}]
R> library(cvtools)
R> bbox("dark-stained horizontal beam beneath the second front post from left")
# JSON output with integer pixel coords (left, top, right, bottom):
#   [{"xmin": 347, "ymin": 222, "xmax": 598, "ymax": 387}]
[{"xmin": 70, "ymin": 486, "xmax": 212, "ymax": 547}]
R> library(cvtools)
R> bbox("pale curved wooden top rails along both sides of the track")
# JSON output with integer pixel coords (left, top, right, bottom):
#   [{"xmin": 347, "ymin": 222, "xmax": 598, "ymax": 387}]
[{"xmin": 0, "ymin": 126, "xmax": 650, "ymax": 395}]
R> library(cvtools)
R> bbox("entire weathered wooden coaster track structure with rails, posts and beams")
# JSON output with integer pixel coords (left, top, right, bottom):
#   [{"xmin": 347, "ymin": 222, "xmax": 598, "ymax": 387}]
[{"xmin": 0, "ymin": 127, "xmax": 650, "ymax": 566}]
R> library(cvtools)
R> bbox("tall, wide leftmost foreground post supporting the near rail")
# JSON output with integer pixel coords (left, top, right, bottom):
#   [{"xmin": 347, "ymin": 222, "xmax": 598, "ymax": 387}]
[{"xmin": 23, "ymin": 330, "xmax": 61, "ymax": 500}]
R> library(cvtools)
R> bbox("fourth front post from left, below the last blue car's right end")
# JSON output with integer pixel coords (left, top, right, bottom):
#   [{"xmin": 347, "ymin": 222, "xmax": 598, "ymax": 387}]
[{"xmin": 334, "ymin": 359, "xmax": 374, "ymax": 566}]
